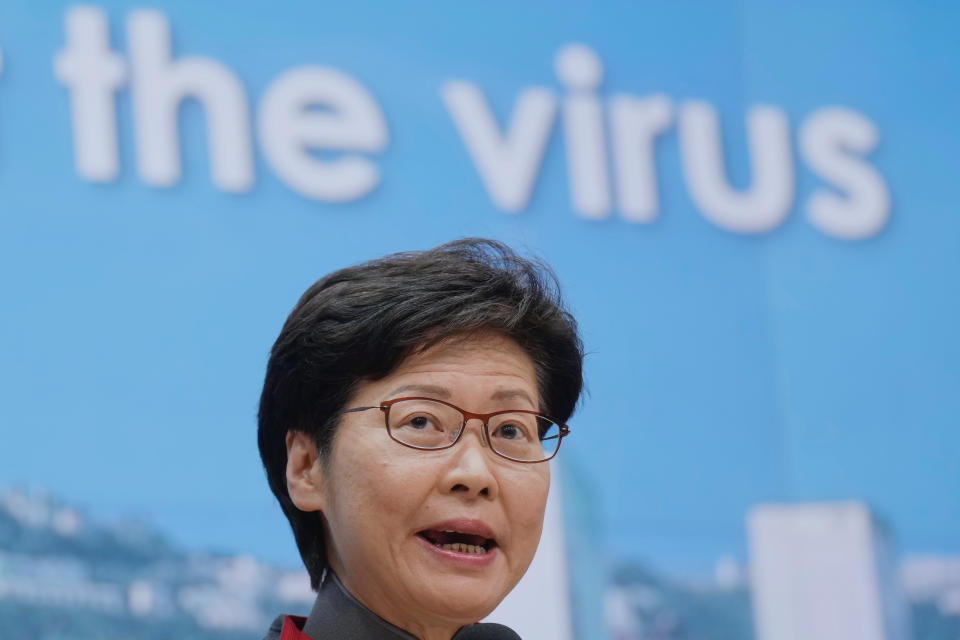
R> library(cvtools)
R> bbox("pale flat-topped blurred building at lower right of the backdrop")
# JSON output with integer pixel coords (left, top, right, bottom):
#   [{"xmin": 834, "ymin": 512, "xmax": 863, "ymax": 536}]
[{"xmin": 747, "ymin": 502, "xmax": 910, "ymax": 640}]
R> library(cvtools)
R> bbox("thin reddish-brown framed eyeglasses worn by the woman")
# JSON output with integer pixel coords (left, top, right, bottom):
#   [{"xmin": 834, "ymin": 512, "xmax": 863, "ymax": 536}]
[{"xmin": 344, "ymin": 398, "xmax": 570, "ymax": 462}]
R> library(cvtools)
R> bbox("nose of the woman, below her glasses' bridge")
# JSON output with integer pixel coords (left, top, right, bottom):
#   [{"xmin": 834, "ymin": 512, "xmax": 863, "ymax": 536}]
[{"xmin": 441, "ymin": 420, "xmax": 500, "ymax": 500}]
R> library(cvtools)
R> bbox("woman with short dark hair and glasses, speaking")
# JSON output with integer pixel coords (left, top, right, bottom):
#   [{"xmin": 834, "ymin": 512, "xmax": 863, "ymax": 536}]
[{"xmin": 258, "ymin": 239, "xmax": 583, "ymax": 640}]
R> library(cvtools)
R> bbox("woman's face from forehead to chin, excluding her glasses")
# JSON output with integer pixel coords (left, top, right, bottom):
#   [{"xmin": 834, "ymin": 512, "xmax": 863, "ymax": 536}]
[{"xmin": 288, "ymin": 334, "xmax": 550, "ymax": 632}]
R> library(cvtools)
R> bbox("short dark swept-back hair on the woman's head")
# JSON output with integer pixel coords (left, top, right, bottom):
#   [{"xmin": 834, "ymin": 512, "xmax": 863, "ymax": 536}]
[{"xmin": 257, "ymin": 238, "xmax": 583, "ymax": 589}]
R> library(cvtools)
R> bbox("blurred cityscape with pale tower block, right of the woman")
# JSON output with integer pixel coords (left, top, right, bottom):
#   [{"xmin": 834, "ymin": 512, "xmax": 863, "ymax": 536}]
[{"xmin": 604, "ymin": 502, "xmax": 960, "ymax": 640}]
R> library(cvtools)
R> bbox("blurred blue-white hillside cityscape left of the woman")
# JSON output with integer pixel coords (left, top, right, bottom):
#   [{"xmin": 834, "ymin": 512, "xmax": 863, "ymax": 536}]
[{"xmin": 0, "ymin": 489, "xmax": 314, "ymax": 640}]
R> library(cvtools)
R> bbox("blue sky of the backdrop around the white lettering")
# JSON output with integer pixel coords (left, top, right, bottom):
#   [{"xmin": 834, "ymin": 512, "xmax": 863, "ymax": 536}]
[{"xmin": 0, "ymin": 1, "xmax": 960, "ymax": 572}]
